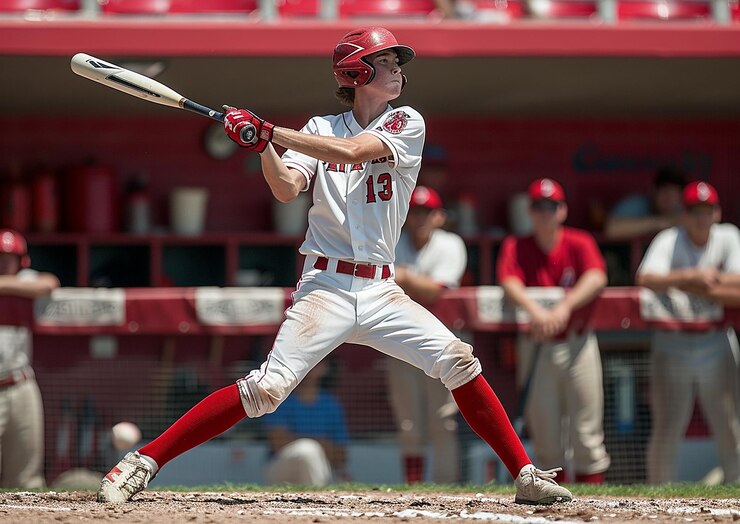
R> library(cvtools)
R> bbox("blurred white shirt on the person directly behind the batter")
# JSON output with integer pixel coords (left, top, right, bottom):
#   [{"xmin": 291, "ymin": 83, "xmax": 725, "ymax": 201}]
[{"xmin": 396, "ymin": 229, "xmax": 468, "ymax": 288}]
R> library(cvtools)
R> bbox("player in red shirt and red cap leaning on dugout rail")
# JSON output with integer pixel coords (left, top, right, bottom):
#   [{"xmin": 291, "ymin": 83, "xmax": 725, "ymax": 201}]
[{"xmin": 497, "ymin": 178, "xmax": 610, "ymax": 483}]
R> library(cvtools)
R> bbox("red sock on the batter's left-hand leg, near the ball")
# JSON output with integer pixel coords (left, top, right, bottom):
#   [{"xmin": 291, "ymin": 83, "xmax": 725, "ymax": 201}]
[{"xmin": 139, "ymin": 384, "xmax": 247, "ymax": 468}]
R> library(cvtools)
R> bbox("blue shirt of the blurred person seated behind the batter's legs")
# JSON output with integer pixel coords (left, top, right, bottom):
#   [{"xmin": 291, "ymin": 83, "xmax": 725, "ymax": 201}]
[{"xmin": 263, "ymin": 392, "xmax": 349, "ymax": 445}]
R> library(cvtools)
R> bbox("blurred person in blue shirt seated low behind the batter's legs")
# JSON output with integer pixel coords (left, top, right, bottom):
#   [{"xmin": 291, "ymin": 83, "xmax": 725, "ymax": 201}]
[{"xmin": 264, "ymin": 360, "xmax": 349, "ymax": 486}]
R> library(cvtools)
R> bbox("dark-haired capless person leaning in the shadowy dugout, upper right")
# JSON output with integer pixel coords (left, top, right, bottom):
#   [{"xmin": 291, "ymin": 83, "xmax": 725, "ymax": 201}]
[{"xmin": 604, "ymin": 167, "xmax": 686, "ymax": 240}]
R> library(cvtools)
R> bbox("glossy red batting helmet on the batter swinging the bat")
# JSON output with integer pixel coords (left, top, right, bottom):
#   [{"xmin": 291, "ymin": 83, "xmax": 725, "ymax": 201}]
[{"xmin": 332, "ymin": 27, "xmax": 416, "ymax": 87}]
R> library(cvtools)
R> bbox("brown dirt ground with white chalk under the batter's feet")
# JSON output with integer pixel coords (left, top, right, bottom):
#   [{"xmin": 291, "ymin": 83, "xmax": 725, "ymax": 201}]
[{"xmin": 0, "ymin": 489, "xmax": 740, "ymax": 524}]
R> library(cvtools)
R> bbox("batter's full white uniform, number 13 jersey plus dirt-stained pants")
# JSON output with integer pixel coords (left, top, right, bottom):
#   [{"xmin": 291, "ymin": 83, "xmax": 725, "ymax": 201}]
[{"xmin": 237, "ymin": 102, "xmax": 481, "ymax": 417}]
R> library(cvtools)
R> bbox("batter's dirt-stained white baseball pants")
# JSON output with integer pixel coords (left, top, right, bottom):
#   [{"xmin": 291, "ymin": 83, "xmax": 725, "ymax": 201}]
[{"xmin": 237, "ymin": 256, "xmax": 481, "ymax": 417}]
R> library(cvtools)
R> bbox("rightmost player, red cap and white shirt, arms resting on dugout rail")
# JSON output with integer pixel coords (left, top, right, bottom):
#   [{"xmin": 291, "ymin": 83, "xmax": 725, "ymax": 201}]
[{"xmin": 637, "ymin": 182, "xmax": 740, "ymax": 483}]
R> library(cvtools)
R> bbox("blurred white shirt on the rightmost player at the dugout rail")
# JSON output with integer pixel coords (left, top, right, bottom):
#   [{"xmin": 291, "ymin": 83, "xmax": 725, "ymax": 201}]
[{"xmin": 637, "ymin": 224, "xmax": 740, "ymax": 275}]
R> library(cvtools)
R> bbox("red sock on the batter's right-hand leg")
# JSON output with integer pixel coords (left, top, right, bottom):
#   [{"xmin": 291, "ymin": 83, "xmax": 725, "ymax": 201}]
[{"xmin": 452, "ymin": 375, "xmax": 532, "ymax": 478}]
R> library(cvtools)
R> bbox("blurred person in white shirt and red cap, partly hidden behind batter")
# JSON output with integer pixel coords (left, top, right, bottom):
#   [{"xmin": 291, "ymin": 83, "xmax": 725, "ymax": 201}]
[{"xmin": 386, "ymin": 186, "xmax": 467, "ymax": 484}]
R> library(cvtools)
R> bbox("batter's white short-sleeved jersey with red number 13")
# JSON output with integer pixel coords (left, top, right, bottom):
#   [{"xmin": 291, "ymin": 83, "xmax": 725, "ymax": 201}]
[{"xmin": 283, "ymin": 105, "xmax": 426, "ymax": 264}]
